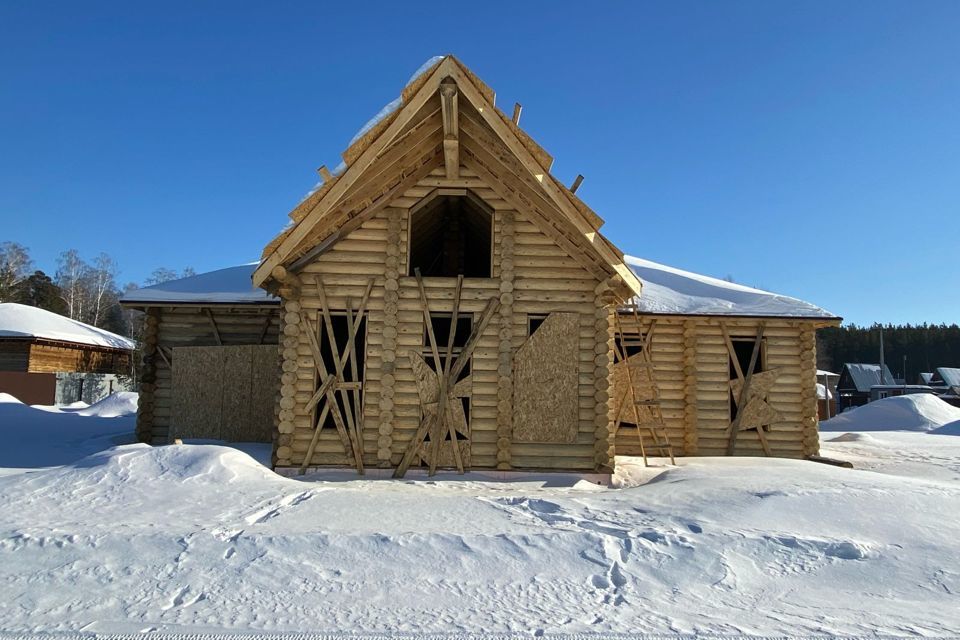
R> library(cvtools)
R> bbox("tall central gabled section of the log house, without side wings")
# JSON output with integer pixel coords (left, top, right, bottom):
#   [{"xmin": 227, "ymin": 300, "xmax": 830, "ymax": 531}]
[{"xmin": 253, "ymin": 57, "xmax": 640, "ymax": 475}]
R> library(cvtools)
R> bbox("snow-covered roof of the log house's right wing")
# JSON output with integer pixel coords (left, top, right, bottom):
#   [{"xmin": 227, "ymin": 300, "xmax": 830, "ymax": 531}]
[{"xmin": 624, "ymin": 256, "xmax": 836, "ymax": 319}]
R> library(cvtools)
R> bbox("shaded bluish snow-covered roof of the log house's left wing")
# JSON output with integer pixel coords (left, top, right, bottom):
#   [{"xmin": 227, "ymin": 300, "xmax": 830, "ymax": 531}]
[{"xmin": 121, "ymin": 262, "xmax": 279, "ymax": 304}]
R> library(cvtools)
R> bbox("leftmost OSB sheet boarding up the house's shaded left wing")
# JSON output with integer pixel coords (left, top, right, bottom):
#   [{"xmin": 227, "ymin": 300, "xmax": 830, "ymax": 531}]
[{"xmin": 170, "ymin": 347, "xmax": 223, "ymax": 440}]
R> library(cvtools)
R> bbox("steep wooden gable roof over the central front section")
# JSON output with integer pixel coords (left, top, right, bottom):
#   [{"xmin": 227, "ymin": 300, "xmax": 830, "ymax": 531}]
[{"xmin": 253, "ymin": 56, "xmax": 641, "ymax": 293}]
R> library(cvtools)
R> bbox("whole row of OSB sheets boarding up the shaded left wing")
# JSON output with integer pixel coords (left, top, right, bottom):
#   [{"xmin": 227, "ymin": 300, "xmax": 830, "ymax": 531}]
[{"xmin": 170, "ymin": 345, "xmax": 279, "ymax": 442}]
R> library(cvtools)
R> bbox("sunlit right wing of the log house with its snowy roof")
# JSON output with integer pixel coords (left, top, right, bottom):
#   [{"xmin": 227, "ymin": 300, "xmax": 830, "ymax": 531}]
[{"xmin": 614, "ymin": 258, "xmax": 839, "ymax": 458}]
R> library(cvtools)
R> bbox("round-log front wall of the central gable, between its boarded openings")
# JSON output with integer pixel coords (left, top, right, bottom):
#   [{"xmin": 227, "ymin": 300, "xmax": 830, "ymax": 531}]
[{"xmin": 276, "ymin": 166, "xmax": 612, "ymax": 470}]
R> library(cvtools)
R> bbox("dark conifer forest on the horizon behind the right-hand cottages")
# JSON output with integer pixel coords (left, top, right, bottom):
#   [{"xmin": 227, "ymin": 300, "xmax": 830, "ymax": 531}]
[{"xmin": 817, "ymin": 324, "xmax": 960, "ymax": 384}]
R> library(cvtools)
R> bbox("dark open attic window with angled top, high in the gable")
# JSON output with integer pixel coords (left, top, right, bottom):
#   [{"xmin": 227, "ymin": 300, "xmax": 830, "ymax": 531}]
[{"xmin": 408, "ymin": 189, "xmax": 493, "ymax": 278}]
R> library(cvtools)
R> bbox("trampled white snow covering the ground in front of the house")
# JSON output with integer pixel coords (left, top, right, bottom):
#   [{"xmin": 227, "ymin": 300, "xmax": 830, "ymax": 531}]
[{"xmin": 0, "ymin": 396, "xmax": 960, "ymax": 636}]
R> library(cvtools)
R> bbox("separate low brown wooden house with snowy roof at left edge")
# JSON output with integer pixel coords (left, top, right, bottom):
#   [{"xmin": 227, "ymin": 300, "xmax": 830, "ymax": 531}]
[{"xmin": 0, "ymin": 302, "xmax": 135, "ymax": 405}]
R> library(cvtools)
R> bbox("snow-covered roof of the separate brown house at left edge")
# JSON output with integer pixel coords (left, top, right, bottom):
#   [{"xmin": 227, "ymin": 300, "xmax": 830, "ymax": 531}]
[{"xmin": 0, "ymin": 302, "xmax": 136, "ymax": 349}]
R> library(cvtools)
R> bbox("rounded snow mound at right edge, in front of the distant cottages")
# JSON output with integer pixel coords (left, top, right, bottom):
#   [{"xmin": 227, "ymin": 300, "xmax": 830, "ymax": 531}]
[{"xmin": 820, "ymin": 393, "xmax": 960, "ymax": 431}]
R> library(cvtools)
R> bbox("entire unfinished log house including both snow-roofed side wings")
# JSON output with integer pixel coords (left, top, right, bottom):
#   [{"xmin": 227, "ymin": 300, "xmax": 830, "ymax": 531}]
[{"xmin": 124, "ymin": 57, "xmax": 839, "ymax": 476}]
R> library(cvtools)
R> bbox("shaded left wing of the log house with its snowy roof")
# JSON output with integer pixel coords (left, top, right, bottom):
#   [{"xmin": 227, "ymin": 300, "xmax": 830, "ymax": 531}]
[{"xmin": 121, "ymin": 265, "xmax": 280, "ymax": 444}]
